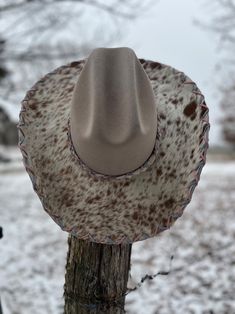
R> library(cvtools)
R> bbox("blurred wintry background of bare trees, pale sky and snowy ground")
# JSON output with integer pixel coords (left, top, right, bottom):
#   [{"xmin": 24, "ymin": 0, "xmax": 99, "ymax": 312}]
[{"xmin": 0, "ymin": 0, "xmax": 235, "ymax": 314}]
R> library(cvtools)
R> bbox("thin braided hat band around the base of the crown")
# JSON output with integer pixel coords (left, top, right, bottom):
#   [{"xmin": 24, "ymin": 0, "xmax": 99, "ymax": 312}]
[{"xmin": 68, "ymin": 118, "xmax": 159, "ymax": 179}]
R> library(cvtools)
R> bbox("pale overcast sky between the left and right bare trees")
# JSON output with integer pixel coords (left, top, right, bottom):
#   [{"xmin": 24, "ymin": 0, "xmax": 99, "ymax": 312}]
[{"xmin": 115, "ymin": 0, "xmax": 221, "ymax": 144}]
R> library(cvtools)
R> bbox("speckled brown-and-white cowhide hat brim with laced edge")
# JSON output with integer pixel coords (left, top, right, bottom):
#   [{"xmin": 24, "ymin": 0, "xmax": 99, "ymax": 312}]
[{"xmin": 18, "ymin": 59, "xmax": 209, "ymax": 244}]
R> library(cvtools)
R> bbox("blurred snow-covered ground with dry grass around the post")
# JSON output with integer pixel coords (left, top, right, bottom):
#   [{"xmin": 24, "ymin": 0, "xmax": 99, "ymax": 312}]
[{"xmin": 0, "ymin": 155, "xmax": 235, "ymax": 314}]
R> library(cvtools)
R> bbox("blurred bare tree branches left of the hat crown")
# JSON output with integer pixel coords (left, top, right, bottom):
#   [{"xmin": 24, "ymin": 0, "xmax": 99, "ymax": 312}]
[{"xmin": 0, "ymin": 0, "xmax": 154, "ymax": 99}]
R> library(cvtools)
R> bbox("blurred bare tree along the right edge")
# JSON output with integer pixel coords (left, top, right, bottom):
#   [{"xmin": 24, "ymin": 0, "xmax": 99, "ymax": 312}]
[{"xmin": 200, "ymin": 0, "xmax": 235, "ymax": 148}]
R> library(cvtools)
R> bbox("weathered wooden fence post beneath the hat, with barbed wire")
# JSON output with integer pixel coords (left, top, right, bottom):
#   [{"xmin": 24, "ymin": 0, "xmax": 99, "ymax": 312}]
[{"xmin": 64, "ymin": 235, "xmax": 132, "ymax": 314}]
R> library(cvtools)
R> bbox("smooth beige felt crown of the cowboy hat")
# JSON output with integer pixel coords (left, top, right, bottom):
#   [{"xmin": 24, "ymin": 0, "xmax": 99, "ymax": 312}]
[{"xmin": 71, "ymin": 47, "xmax": 157, "ymax": 175}]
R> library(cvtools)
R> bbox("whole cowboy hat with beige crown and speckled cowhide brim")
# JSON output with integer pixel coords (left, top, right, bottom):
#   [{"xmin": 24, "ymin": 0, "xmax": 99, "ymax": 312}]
[{"xmin": 18, "ymin": 48, "xmax": 209, "ymax": 244}]
